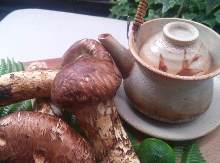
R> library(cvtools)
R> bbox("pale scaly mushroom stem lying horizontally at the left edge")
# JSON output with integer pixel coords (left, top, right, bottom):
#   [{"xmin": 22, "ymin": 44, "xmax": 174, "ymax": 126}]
[{"xmin": 0, "ymin": 70, "xmax": 58, "ymax": 106}]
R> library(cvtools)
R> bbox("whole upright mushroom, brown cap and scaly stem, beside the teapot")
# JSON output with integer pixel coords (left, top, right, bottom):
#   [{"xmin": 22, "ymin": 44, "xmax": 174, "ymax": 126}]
[{"xmin": 51, "ymin": 39, "xmax": 139, "ymax": 163}]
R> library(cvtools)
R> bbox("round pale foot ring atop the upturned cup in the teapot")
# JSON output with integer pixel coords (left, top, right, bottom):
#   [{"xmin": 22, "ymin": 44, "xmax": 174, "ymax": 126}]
[{"xmin": 163, "ymin": 21, "xmax": 199, "ymax": 46}]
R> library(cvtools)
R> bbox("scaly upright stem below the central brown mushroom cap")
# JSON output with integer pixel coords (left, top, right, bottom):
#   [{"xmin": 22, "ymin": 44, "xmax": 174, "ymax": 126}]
[{"xmin": 74, "ymin": 99, "xmax": 140, "ymax": 163}]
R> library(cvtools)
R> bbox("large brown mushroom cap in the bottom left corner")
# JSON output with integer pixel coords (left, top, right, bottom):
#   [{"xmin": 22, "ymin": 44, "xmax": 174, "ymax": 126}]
[{"xmin": 0, "ymin": 112, "xmax": 95, "ymax": 163}]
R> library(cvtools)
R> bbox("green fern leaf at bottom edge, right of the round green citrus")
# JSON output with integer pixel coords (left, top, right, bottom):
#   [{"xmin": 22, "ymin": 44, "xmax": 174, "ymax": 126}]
[{"xmin": 181, "ymin": 143, "xmax": 205, "ymax": 163}]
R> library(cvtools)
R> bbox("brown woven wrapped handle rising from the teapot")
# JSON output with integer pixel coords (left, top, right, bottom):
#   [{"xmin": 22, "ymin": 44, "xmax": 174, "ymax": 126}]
[{"xmin": 132, "ymin": 0, "xmax": 148, "ymax": 32}]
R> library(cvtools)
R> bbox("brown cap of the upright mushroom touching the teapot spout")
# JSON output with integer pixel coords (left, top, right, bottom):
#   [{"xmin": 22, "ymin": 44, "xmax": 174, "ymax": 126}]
[{"xmin": 51, "ymin": 39, "xmax": 121, "ymax": 109}]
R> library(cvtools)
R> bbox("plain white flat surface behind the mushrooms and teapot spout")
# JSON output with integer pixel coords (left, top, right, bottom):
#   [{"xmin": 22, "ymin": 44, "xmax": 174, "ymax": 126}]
[{"xmin": 0, "ymin": 9, "xmax": 128, "ymax": 61}]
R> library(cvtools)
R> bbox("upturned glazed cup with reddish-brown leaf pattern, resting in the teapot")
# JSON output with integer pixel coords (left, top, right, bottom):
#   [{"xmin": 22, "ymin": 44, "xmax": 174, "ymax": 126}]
[{"xmin": 140, "ymin": 22, "xmax": 211, "ymax": 76}]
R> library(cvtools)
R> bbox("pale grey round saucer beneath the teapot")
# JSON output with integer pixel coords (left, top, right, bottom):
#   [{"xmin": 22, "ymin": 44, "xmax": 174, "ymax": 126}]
[{"xmin": 115, "ymin": 77, "xmax": 220, "ymax": 141}]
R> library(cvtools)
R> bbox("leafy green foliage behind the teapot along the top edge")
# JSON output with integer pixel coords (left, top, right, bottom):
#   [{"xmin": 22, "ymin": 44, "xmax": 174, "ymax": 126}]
[{"xmin": 110, "ymin": 0, "xmax": 220, "ymax": 29}]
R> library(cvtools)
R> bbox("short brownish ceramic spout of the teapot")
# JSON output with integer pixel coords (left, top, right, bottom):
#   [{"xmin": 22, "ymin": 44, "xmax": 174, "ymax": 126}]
[{"xmin": 98, "ymin": 33, "xmax": 134, "ymax": 78}]
